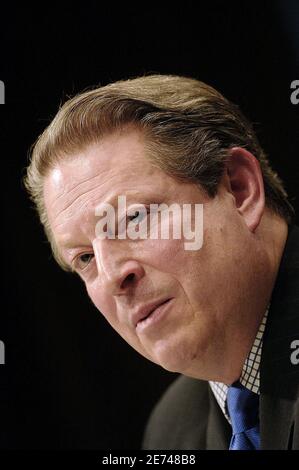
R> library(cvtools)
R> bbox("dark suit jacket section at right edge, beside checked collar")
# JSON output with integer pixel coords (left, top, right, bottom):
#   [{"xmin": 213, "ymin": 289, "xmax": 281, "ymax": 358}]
[{"xmin": 260, "ymin": 227, "xmax": 299, "ymax": 449}]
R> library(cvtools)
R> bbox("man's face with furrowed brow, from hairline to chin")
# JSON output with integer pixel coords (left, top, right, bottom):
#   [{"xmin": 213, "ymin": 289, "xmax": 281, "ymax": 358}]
[{"xmin": 44, "ymin": 129, "xmax": 255, "ymax": 379}]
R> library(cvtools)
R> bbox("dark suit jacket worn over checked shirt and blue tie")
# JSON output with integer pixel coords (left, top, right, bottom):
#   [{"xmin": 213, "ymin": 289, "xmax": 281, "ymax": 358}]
[{"xmin": 143, "ymin": 226, "xmax": 299, "ymax": 450}]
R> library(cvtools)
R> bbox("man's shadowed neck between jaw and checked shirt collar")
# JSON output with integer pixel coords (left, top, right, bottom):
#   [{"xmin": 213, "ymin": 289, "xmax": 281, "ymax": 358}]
[{"xmin": 182, "ymin": 209, "xmax": 288, "ymax": 385}]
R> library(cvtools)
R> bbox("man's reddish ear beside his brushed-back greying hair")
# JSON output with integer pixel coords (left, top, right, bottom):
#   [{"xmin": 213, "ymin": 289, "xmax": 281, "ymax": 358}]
[{"xmin": 226, "ymin": 147, "xmax": 265, "ymax": 232}]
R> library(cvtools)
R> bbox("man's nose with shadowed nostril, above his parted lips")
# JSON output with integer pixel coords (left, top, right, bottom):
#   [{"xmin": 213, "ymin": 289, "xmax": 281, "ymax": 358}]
[{"xmin": 93, "ymin": 239, "xmax": 145, "ymax": 296}]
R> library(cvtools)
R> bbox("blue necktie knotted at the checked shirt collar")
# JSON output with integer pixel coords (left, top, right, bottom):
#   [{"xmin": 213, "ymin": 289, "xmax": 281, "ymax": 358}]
[{"xmin": 226, "ymin": 382, "xmax": 260, "ymax": 450}]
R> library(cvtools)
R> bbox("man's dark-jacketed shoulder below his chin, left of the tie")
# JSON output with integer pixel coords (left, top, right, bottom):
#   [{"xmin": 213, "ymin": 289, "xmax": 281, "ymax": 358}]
[{"xmin": 143, "ymin": 375, "xmax": 209, "ymax": 449}]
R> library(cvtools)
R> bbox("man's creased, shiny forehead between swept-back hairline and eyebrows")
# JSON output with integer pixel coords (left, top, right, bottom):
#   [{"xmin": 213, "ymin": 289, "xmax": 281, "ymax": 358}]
[{"xmin": 44, "ymin": 130, "xmax": 183, "ymax": 242}]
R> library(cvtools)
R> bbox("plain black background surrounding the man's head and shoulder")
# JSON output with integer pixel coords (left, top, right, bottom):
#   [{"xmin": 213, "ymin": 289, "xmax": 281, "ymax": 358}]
[{"xmin": 0, "ymin": 0, "xmax": 299, "ymax": 449}]
